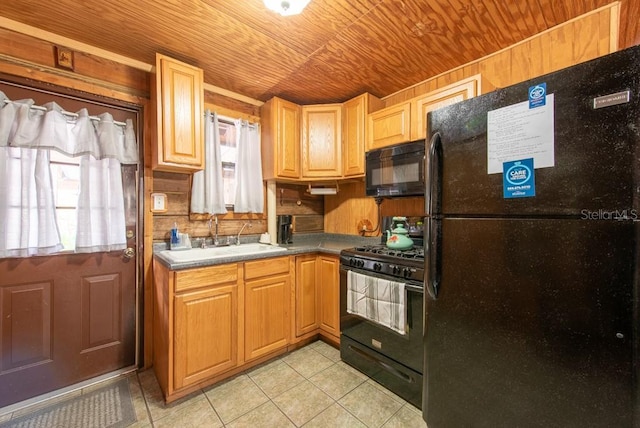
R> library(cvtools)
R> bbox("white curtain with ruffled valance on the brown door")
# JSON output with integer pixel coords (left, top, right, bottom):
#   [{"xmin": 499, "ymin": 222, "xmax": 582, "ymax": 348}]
[{"xmin": 0, "ymin": 92, "xmax": 138, "ymax": 257}]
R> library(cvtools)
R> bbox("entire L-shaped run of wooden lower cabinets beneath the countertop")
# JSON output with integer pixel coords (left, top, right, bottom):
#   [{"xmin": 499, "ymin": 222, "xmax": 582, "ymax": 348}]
[{"xmin": 153, "ymin": 254, "xmax": 340, "ymax": 402}]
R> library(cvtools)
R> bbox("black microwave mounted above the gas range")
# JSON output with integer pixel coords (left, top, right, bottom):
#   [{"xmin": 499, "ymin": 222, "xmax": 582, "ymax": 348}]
[{"xmin": 365, "ymin": 140, "xmax": 426, "ymax": 197}]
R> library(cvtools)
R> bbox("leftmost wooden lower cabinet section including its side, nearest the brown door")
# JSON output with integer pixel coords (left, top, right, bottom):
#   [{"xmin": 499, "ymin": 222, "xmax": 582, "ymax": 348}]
[{"xmin": 153, "ymin": 260, "xmax": 243, "ymax": 402}]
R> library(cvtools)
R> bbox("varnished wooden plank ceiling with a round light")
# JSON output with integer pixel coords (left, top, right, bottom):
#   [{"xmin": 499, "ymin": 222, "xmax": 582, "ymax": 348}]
[{"xmin": 0, "ymin": 0, "xmax": 640, "ymax": 104}]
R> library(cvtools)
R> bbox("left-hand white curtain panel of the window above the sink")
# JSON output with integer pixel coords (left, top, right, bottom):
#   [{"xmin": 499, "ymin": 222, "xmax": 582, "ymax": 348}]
[{"xmin": 191, "ymin": 110, "xmax": 227, "ymax": 214}]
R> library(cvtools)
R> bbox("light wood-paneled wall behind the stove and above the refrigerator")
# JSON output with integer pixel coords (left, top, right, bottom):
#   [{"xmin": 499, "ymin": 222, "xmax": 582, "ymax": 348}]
[{"xmin": 325, "ymin": 4, "xmax": 619, "ymax": 235}]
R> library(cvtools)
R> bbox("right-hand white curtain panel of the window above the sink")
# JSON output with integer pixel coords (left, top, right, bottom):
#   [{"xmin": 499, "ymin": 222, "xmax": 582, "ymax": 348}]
[{"xmin": 233, "ymin": 120, "xmax": 264, "ymax": 213}]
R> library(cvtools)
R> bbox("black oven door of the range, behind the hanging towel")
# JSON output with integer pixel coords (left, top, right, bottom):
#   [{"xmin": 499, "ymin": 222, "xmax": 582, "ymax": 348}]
[{"xmin": 340, "ymin": 265, "xmax": 424, "ymax": 373}]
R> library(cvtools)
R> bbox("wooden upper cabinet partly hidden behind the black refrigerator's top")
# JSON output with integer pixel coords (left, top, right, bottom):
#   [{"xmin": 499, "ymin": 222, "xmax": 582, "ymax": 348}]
[{"xmin": 411, "ymin": 74, "xmax": 480, "ymax": 140}]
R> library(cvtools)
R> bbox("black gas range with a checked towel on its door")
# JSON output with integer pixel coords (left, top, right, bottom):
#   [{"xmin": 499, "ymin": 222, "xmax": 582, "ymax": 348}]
[{"xmin": 340, "ymin": 244, "xmax": 425, "ymax": 408}]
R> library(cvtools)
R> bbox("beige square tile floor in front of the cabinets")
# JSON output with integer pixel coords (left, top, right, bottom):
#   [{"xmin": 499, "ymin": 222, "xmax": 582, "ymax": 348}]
[{"xmin": 0, "ymin": 341, "xmax": 426, "ymax": 428}]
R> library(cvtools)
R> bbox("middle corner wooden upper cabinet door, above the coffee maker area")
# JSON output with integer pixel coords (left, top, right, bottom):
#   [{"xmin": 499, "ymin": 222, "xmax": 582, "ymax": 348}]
[{"xmin": 302, "ymin": 104, "xmax": 342, "ymax": 178}]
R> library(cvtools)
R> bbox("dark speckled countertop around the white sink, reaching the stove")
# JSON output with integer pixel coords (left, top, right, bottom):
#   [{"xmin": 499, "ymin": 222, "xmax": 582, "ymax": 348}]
[{"xmin": 153, "ymin": 233, "xmax": 380, "ymax": 270}]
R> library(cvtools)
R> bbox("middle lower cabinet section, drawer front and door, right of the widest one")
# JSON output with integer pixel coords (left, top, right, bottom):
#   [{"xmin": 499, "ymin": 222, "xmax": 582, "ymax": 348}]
[{"xmin": 244, "ymin": 257, "xmax": 291, "ymax": 361}]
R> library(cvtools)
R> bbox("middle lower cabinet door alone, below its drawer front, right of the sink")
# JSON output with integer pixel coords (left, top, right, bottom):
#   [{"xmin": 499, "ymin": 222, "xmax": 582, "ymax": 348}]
[{"xmin": 244, "ymin": 274, "xmax": 291, "ymax": 361}]
